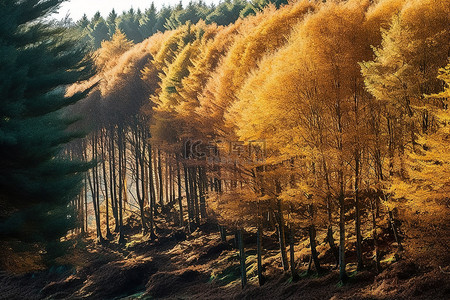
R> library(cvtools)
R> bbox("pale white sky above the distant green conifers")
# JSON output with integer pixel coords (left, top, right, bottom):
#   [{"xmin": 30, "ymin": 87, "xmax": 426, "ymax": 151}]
[{"xmin": 54, "ymin": 0, "xmax": 220, "ymax": 21}]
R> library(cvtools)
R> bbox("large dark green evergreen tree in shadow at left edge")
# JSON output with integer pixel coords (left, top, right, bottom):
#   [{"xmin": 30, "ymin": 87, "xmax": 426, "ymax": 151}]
[{"xmin": 0, "ymin": 0, "xmax": 90, "ymax": 253}]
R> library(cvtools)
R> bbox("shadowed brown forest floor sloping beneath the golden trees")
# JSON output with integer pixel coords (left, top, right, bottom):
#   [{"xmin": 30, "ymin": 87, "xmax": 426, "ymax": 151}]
[{"xmin": 0, "ymin": 213, "xmax": 450, "ymax": 300}]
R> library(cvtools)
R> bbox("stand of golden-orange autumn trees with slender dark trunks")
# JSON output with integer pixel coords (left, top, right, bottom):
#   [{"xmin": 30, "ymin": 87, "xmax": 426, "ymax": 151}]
[{"xmin": 68, "ymin": 0, "xmax": 450, "ymax": 284}]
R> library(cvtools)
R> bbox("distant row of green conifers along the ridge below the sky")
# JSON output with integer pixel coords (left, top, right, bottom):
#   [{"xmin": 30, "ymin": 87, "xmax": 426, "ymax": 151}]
[{"xmin": 71, "ymin": 0, "xmax": 287, "ymax": 49}]
